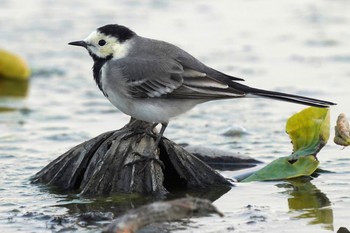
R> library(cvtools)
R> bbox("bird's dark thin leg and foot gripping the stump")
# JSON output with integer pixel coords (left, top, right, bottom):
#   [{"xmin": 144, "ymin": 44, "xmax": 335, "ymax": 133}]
[{"xmin": 124, "ymin": 123, "xmax": 168, "ymax": 171}]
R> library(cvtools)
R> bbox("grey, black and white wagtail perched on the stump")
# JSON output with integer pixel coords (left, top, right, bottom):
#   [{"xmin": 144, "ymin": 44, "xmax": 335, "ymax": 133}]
[{"xmin": 68, "ymin": 24, "xmax": 335, "ymax": 164}]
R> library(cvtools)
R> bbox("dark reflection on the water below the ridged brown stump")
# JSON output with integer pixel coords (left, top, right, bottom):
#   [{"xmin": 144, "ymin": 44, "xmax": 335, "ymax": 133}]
[{"xmin": 20, "ymin": 186, "xmax": 231, "ymax": 232}]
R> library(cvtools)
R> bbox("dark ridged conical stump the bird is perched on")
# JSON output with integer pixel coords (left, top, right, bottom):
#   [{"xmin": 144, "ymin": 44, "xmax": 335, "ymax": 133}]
[{"xmin": 32, "ymin": 119, "xmax": 232, "ymax": 196}]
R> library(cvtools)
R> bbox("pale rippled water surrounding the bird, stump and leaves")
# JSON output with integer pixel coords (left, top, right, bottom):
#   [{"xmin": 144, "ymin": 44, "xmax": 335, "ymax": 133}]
[{"xmin": 0, "ymin": 0, "xmax": 350, "ymax": 232}]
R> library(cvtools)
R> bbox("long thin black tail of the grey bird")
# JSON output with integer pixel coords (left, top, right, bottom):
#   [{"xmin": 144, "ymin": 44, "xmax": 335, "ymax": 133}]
[{"xmin": 244, "ymin": 86, "xmax": 336, "ymax": 108}]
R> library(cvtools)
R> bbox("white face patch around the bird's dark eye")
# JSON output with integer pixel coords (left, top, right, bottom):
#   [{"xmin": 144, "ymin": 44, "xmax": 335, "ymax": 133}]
[{"xmin": 84, "ymin": 31, "xmax": 131, "ymax": 59}]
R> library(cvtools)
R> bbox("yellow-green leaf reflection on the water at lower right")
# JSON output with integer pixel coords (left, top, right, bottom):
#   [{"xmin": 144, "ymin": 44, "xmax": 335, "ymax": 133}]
[{"xmin": 277, "ymin": 178, "xmax": 334, "ymax": 231}]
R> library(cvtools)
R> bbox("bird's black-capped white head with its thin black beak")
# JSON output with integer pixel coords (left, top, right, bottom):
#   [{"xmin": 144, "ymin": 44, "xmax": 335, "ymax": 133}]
[{"xmin": 69, "ymin": 24, "xmax": 136, "ymax": 61}]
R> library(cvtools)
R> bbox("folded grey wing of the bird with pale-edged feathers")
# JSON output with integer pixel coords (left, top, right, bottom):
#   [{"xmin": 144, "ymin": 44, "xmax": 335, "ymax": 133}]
[{"xmin": 118, "ymin": 57, "xmax": 245, "ymax": 100}]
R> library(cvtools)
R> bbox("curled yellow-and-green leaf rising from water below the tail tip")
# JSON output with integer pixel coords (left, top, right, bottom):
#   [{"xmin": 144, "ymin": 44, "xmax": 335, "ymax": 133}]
[{"xmin": 242, "ymin": 107, "xmax": 329, "ymax": 182}]
